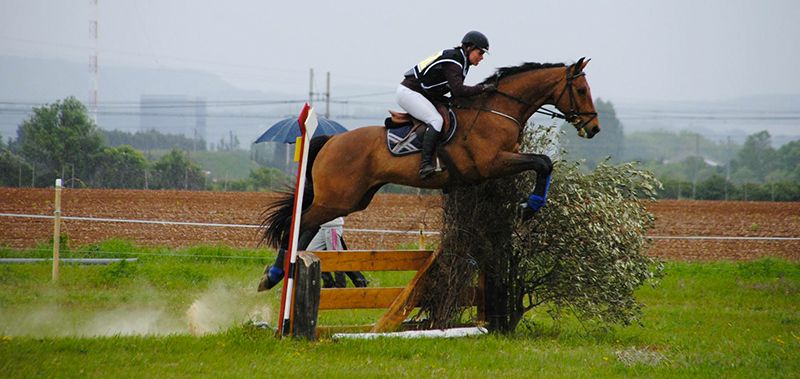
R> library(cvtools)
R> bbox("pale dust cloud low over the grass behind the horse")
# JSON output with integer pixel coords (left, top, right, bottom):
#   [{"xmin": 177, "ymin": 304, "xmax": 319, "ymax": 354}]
[{"xmin": 0, "ymin": 281, "xmax": 273, "ymax": 338}]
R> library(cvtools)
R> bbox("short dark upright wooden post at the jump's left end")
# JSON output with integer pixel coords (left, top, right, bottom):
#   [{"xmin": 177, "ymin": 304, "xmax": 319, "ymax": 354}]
[{"xmin": 291, "ymin": 251, "xmax": 320, "ymax": 341}]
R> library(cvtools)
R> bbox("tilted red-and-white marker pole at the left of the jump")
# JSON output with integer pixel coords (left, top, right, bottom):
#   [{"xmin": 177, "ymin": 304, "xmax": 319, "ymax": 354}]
[{"xmin": 278, "ymin": 103, "xmax": 317, "ymax": 337}]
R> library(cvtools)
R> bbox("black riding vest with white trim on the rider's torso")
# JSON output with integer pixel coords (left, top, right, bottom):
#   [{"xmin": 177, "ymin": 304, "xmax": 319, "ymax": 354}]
[{"xmin": 405, "ymin": 48, "xmax": 469, "ymax": 96}]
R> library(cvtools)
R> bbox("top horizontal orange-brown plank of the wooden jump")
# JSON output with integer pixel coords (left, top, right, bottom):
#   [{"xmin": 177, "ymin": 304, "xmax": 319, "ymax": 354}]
[{"xmin": 312, "ymin": 250, "xmax": 433, "ymax": 272}]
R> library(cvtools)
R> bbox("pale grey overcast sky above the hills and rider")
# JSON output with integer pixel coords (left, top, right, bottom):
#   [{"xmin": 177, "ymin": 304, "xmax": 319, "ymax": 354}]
[{"xmin": 0, "ymin": 0, "xmax": 800, "ymax": 101}]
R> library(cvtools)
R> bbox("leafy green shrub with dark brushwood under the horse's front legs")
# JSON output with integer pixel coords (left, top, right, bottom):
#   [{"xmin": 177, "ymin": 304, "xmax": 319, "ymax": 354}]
[{"xmin": 432, "ymin": 126, "xmax": 663, "ymax": 331}]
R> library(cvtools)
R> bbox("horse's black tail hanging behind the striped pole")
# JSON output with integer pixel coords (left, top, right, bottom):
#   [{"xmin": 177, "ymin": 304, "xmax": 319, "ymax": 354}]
[{"xmin": 261, "ymin": 136, "xmax": 330, "ymax": 248}]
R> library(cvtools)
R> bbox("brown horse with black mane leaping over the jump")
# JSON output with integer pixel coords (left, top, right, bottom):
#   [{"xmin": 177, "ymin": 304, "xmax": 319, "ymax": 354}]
[{"xmin": 262, "ymin": 58, "xmax": 600, "ymax": 248}]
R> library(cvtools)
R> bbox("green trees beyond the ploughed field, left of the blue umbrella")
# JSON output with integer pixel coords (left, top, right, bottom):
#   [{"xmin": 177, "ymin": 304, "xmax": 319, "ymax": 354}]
[{"xmin": 0, "ymin": 97, "xmax": 285, "ymax": 190}]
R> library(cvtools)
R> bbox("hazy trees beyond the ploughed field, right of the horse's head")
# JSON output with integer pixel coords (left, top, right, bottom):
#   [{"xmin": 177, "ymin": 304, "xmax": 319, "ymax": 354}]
[{"xmin": 561, "ymin": 100, "xmax": 800, "ymax": 201}]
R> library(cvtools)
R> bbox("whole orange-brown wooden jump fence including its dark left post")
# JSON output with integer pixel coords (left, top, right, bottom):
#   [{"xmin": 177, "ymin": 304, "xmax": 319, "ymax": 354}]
[{"xmin": 292, "ymin": 250, "xmax": 482, "ymax": 339}]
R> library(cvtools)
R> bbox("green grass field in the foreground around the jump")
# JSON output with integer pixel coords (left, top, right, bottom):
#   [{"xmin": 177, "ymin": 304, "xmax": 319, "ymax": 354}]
[{"xmin": 0, "ymin": 241, "xmax": 800, "ymax": 378}]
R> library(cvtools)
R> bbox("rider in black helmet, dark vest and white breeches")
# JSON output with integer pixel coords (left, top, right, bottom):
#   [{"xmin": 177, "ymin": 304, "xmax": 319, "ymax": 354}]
[{"xmin": 397, "ymin": 30, "xmax": 496, "ymax": 179}]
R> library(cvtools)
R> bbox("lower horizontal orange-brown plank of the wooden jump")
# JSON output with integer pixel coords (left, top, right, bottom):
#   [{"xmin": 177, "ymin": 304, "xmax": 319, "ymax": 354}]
[{"xmin": 319, "ymin": 287, "xmax": 403, "ymax": 310}]
